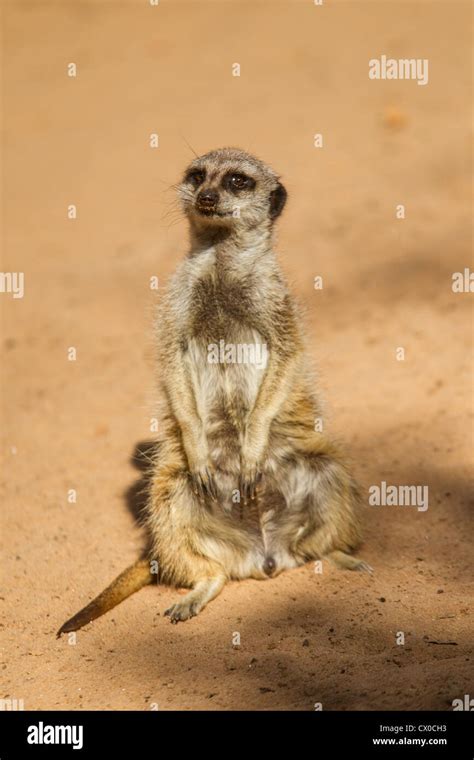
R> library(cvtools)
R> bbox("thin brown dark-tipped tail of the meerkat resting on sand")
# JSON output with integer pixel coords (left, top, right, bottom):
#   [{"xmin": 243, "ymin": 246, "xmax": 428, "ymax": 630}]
[{"xmin": 56, "ymin": 559, "xmax": 156, "ymax": 638}]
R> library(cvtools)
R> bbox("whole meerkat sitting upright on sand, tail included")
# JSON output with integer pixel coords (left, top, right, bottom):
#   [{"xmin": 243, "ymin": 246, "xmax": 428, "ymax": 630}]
[{"xmin": 58, "ymin": 148, "xmax": 371, "ymax": 635}]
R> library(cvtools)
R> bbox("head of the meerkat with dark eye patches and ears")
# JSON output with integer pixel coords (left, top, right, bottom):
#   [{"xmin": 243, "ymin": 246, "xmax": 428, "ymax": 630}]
[{"xmin": 178, "ymin": 148, "xmax": 287, "ymax": 229}]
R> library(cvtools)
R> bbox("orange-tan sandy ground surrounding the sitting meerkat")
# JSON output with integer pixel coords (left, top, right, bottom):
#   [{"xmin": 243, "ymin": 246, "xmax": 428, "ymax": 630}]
[{"xmin": 0, "ymin": 0, "xmax": 474, "ymax": 710}]
